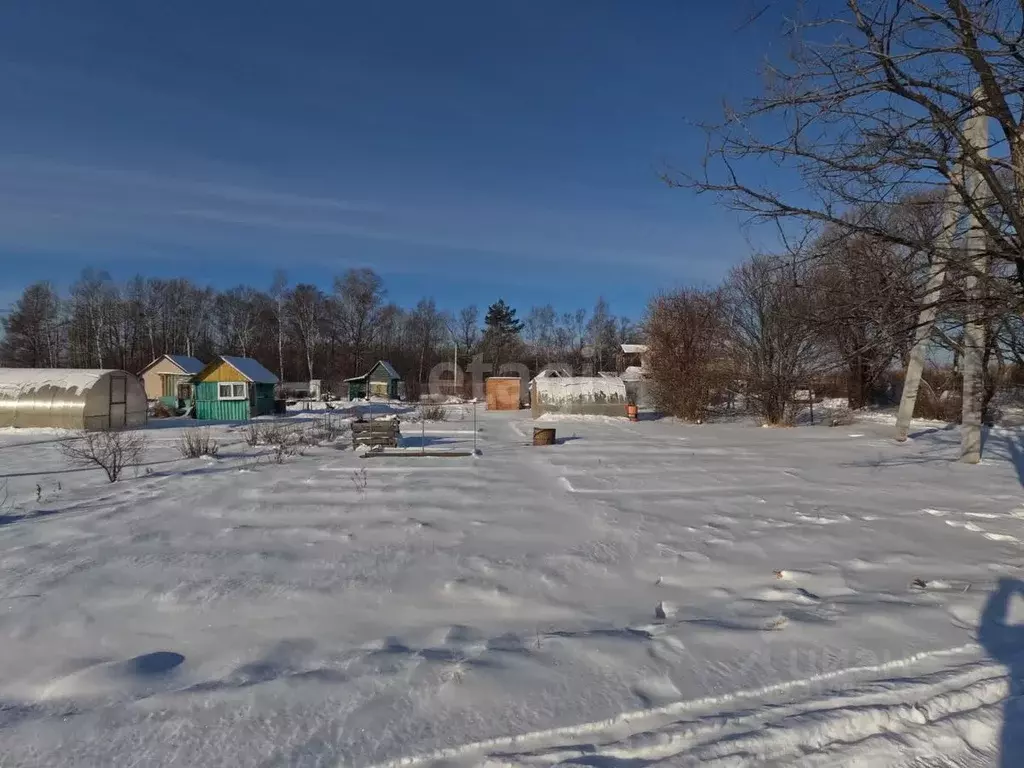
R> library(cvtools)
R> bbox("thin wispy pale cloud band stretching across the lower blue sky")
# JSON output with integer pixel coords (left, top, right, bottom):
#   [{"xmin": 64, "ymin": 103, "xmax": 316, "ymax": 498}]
[{"xmin": 0, "ymin": 156, "xmax": 738, "ymax": 275}]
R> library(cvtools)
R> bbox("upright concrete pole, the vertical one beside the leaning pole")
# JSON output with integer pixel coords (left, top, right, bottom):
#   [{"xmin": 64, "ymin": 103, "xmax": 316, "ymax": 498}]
[{"xmin": 961, "ymin": 91, "xmax": 988, "ymax": 464}]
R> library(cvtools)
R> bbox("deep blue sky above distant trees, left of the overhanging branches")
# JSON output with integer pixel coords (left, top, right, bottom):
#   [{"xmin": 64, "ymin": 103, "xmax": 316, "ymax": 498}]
[{"xmin": 0, "ymin": 0, "xmax": 778, "ymax": 316}]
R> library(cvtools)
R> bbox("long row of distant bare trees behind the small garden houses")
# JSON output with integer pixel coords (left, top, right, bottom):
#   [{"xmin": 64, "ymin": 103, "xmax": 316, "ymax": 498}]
[{"xmin": 0, "ymin": 268, "xmax": 638, "ymax": 393}]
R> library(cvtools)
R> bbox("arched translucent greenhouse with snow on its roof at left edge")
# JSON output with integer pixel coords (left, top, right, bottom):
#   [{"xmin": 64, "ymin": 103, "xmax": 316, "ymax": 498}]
[{"xmin": 0, "ymin": 368, "xmax": 147, "ymax": 429}]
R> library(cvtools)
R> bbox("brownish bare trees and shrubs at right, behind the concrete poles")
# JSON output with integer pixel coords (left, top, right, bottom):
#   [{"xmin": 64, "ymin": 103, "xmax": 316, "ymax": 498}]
[{"xmin": 644, "ymin": 187, "xmax": 1024, "ymax": 424}]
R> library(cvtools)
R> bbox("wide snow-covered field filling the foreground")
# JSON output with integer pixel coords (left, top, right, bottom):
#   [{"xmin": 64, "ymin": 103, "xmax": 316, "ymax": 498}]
[{"xmin": 0, "ymin": 411, "xmax": 1024, "ymax": 767}]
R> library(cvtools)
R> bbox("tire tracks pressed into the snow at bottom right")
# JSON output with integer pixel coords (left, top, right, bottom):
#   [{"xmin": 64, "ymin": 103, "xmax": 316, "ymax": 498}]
[{"xmin": 362, "ymin": 643, "xmax": 983, "ymax": 768}]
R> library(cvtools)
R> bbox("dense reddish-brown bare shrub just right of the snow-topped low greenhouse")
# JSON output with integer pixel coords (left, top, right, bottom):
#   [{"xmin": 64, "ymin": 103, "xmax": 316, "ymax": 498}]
[{"xmin": 645, "ymin": 290, "xmax": 731, "ymax": 421}]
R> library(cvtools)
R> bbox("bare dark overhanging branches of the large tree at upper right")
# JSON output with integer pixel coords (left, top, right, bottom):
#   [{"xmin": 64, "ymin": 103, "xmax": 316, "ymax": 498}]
[{"xmin": 679, "ymin": 0, "xmax": 1024, "ymax": 289}]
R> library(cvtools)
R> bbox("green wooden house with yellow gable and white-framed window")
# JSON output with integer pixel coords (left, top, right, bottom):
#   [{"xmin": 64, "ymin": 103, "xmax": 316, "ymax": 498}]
[{"xmin": 195, "ymin": 354, "xmax": 278, "ymax": 421}]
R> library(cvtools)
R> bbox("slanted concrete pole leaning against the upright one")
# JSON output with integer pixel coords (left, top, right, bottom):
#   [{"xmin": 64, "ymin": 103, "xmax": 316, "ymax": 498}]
[{"xmin": 896, "ymin": 172, "xmax": 959, "ymax": 442}]
